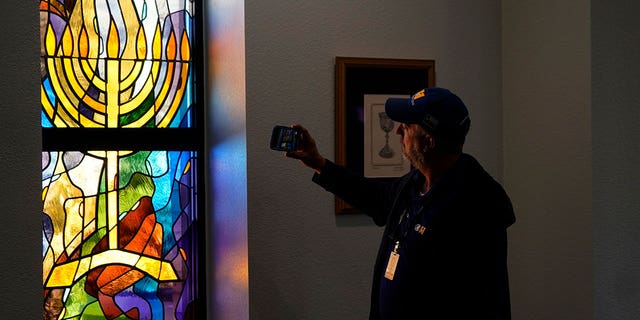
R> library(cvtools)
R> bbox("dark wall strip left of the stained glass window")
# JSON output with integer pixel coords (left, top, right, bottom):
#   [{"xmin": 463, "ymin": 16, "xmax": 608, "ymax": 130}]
[{"xmin": 0, "ymin": 1, "xmax": 42, "ymax": 319}]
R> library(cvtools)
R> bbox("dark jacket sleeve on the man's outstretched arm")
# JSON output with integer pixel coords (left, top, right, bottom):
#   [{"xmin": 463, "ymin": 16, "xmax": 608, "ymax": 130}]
[{"xmin": 313, "ymin": 160, "xmax": 399, "ymax": 226}]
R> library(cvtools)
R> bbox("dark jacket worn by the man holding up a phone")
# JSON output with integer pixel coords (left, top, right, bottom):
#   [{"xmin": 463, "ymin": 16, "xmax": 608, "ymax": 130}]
[{"xmin": 313, "ymin": 154, "xmax": 515, "ymax": 320}]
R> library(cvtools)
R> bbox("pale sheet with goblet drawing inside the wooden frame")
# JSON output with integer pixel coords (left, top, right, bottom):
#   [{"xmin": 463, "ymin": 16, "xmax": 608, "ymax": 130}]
[{"xmin": 363, "ymin": 94, "xmax": 411, "ymax": 178}]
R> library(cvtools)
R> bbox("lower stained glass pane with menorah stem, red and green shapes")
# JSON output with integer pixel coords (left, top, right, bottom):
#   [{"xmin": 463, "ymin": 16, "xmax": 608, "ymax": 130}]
[{"xmin": 42, "ymin": 151, "xmax": 198, "ymax": 319}]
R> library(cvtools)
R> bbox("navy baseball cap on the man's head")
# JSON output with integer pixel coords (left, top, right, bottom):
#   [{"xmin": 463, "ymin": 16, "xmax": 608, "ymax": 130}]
[{"xmin": 385, "ymin": 87, "xmax": 470, "ymax": 135}]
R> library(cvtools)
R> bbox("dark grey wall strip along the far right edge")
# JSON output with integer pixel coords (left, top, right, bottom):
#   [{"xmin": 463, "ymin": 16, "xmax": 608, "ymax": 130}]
[{"xmin": 591, "ymin": 0, "xmax": 640, "ymax": 320}]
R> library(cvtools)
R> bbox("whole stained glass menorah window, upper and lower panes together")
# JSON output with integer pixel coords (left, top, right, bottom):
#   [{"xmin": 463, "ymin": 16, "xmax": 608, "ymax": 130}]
[{"xmin": 40, "ymin": 0, "xmax": 198, "ymax": 319}]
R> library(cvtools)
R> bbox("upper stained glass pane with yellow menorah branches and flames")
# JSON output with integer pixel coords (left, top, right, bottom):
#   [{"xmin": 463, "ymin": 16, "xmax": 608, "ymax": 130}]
[{"xmin": 40, "ymin": 0, "xmax": 194, "ymax": 128}]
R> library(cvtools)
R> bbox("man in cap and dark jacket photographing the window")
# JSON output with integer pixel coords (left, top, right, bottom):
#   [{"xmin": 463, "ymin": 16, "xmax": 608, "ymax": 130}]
[{"xmin": 286, "ymin": 87, "xmax": 515, "ymax": 320}]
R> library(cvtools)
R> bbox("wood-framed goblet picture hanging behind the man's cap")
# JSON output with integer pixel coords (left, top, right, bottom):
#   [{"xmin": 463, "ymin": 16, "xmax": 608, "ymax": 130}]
[{"xmin": 335, "ymin": 57, "xmax": 435, "ymax": 214}]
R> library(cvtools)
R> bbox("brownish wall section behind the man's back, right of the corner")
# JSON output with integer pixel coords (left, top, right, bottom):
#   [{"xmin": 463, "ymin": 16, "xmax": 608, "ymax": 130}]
[{"xmin": 502, "ymin": 0, "xmax": 593, "ymax": 319}]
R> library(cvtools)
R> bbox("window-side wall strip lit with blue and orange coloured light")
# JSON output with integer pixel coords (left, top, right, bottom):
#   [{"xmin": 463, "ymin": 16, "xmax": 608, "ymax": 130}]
[{"xmin": 206, "ymin": 0, "xmax": 249, "ymax": 319}]
